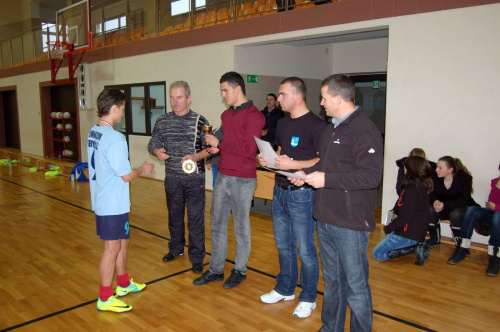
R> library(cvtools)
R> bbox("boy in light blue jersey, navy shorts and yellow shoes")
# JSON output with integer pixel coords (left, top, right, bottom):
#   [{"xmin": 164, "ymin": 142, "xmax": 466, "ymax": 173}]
[{"xmin": 87, "ymin": 89, "xmax": 154, "ymax": 312}]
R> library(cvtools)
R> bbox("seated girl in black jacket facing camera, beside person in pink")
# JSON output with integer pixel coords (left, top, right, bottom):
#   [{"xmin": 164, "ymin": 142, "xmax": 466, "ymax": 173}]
[{"xmin": 427, "ymin": 156, "xmax": 479, "ymax": 247}]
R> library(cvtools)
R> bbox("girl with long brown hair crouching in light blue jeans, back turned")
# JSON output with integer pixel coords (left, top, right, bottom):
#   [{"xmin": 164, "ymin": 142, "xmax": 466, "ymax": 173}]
[{"xmin": 372, "ymin": 156, "xmax": 433, "ymax": 265}]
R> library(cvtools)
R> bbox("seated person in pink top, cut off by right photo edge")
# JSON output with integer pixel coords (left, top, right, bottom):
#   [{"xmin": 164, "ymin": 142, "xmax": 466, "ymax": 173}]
[{"xmin": 448, "ymin": 165, "xmax": 500, "ymax": 277}]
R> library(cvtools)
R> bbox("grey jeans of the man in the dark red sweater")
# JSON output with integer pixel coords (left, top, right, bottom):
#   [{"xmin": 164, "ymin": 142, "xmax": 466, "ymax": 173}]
[{"xmin": 210, "ymin": 173, "xmax": 257, "ymax": 273}]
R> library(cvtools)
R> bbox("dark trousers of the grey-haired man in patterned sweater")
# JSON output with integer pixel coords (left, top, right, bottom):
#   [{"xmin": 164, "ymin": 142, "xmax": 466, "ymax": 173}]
[{"xmin": 165, "ymin": 177, "xmax": 205, "ymax": 264}]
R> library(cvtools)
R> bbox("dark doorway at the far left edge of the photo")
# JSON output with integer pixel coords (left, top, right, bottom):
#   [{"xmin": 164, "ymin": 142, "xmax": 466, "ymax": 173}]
[{"xmin": 0, "ymin": 89, "xmax": 21, "ymax": 150}]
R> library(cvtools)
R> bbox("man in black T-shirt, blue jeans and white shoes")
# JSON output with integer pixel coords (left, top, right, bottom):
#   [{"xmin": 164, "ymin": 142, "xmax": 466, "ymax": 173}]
[{"xmin": 259, "ymin": 77, "xmax": 327, "ymax": 318}]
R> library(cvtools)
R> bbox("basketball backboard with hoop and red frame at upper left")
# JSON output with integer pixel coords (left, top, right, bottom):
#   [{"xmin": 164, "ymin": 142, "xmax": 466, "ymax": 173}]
[{"xmin": 47, "ymin": 0, "xmax": 93, "ymax": 84}]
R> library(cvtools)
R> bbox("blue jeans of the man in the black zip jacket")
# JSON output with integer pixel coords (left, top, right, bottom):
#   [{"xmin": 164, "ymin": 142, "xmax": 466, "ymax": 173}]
[{"xmin": 317, "ymin": 221, "xmax": 373, "ymax": 332}]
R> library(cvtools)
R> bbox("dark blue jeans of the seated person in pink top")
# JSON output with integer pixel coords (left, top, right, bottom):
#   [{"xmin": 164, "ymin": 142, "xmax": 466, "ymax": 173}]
[{"xmin": 460, "ymin": 206, "xmax": 500, "ymax": 247}]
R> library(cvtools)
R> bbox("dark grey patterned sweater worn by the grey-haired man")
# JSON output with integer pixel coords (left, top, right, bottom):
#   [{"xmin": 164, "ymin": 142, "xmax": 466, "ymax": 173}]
[{"xmin": 148, "ymin": 110, "xmax": 208, "ymax": 178}]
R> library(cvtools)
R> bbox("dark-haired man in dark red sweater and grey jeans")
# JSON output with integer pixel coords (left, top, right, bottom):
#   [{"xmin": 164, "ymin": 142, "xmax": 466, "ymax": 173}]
[{"xmin": 193, "ymin": 72, "xmax": 265, "ymax": 288}]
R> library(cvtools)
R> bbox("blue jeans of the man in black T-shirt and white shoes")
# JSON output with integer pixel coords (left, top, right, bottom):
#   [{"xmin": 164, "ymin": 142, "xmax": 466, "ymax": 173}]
[{"xmin": 273, "ymin": 185, "xmax": 319, "ymax": 302}]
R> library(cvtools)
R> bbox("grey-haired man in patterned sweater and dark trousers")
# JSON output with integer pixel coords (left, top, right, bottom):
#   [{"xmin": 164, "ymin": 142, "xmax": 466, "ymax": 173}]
[{"xmin": 148, "ymin": 81, "xmax": 209, "ymax": 273}]
